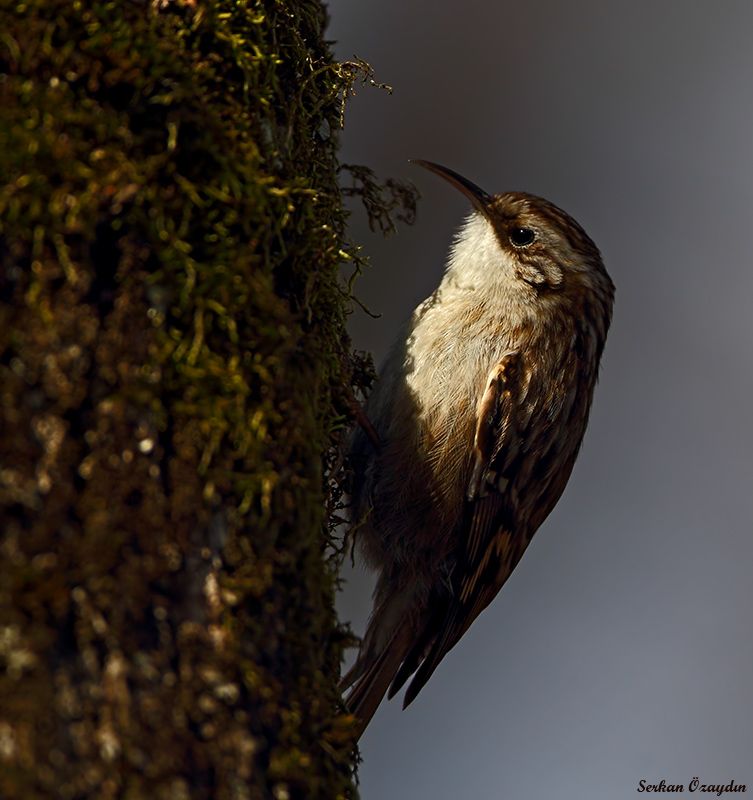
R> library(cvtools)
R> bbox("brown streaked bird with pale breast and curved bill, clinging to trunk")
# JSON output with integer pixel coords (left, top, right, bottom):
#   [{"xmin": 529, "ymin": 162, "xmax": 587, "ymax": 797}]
[{"xmin": 341, "ymin": 160, "xmax": 615, "ymax": 738}]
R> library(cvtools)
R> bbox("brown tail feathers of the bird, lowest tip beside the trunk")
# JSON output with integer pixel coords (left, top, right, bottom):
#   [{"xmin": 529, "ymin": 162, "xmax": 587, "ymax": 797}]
[{"xmin": 340, "ymin": 615, "xmax": 413, "ymax": 738}]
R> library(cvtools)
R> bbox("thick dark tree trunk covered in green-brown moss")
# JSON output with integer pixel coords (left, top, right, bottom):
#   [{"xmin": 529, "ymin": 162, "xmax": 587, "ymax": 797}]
[{"xmin": 0, "ymin": 0, "xmax": 362, "ymax": 800}]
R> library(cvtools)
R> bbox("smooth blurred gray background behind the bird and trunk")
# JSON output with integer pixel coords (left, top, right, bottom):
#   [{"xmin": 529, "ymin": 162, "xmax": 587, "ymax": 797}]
[{"xmin": 329, "ymin": 0, "xmax": 753, "ymax": 800}]
